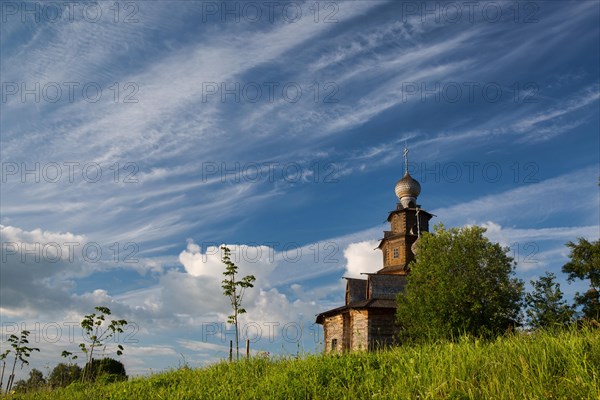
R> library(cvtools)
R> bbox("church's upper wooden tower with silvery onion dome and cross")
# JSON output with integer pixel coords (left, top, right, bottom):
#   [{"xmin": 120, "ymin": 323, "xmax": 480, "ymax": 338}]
[{"xmin": 377, "ymin": 148, "xmax": 433, "ymax": 275}]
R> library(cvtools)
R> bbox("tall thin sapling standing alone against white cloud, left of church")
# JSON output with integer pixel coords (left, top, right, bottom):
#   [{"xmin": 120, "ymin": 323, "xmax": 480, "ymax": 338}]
[{"xmin": 221, "ymin": 246, "xmax": 256, "ymax": 360}]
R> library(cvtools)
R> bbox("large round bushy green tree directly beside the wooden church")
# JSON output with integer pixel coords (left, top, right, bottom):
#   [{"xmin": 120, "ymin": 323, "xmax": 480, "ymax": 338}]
[{"xmin": 397, "ymin": 225, "xmax": 523, "ymax": 341}]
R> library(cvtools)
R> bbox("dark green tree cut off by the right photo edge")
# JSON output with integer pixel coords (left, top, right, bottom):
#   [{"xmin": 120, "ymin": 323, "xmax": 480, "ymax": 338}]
[{"xmin": 562, "ymin": 238, "xmax": 600, "ymax": 321}]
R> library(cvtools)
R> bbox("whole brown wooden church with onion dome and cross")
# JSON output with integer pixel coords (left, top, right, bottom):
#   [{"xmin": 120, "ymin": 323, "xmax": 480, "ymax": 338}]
[{"xmin": 316, "ymin": 149, "xmax": 433, "ymax": 352}]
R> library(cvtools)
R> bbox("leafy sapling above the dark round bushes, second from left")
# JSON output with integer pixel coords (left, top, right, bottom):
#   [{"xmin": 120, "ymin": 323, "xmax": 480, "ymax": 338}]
[{"xmin": 78, "ymin": 307, "xmax": 127, "ymax": 382}]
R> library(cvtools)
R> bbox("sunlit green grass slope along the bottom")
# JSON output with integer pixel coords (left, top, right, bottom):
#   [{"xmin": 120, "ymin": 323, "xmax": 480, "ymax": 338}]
[{"xmin": 9, "ymin": 329, "xmax": 600, "ymax": 400}]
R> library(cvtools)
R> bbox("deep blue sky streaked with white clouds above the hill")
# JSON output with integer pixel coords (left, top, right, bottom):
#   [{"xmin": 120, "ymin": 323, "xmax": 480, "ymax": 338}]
[{"xmin": 0, "ymin": 1, "xmax": 600, "ymax": 375}]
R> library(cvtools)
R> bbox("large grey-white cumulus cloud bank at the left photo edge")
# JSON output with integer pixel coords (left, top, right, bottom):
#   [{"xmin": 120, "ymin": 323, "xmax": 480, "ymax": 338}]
[{"xmin": 0, "ymin": 225, "xmax": 171, "ymax": 318}]
